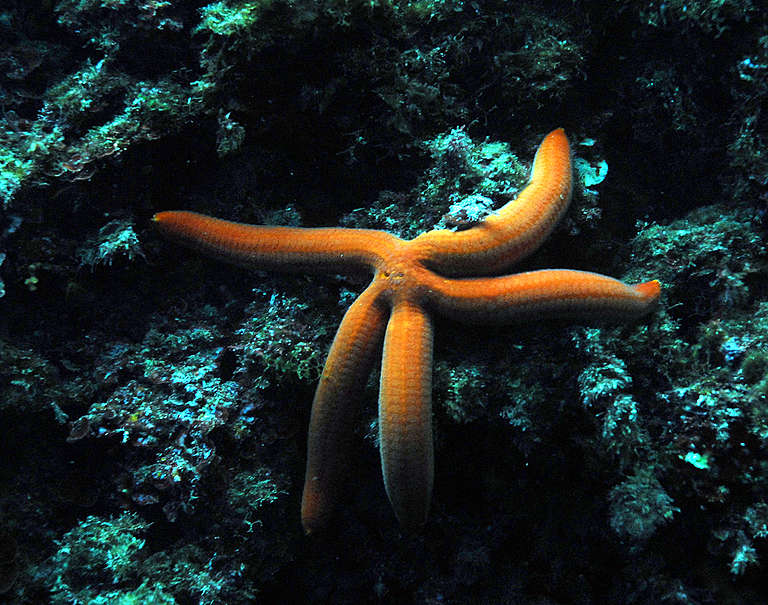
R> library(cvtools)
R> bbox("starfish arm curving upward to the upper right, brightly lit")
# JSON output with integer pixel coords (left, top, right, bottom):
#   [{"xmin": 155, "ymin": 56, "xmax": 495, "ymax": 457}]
[{"xmin": 411, "ymin": 128, "xmax": 573, "ymax": 275}]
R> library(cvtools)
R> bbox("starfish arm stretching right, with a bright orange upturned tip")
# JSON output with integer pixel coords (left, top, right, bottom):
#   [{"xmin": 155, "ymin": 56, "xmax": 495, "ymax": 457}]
[{"xmin": 420, "ymin": 269, "xmax": 661, "ymax": 324}]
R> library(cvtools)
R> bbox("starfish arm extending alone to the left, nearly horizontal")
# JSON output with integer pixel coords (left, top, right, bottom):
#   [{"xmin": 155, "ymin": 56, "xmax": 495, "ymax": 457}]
[{"xmin": 152, "ymin": 211, "xmax": 401, "ymax": 272}]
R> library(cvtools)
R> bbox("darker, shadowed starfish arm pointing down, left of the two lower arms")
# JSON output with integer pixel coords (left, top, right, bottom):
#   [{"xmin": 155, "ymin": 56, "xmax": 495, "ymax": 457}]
[{"xmin": 301, "ymin": 282, "xmax": 388, "ymax": 534}]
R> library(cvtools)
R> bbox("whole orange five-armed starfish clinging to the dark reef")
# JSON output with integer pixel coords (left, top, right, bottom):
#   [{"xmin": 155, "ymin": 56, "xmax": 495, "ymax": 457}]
[{"xmin": 153, "ymin": 129, "xmax": 660, "ymax": 533}]
